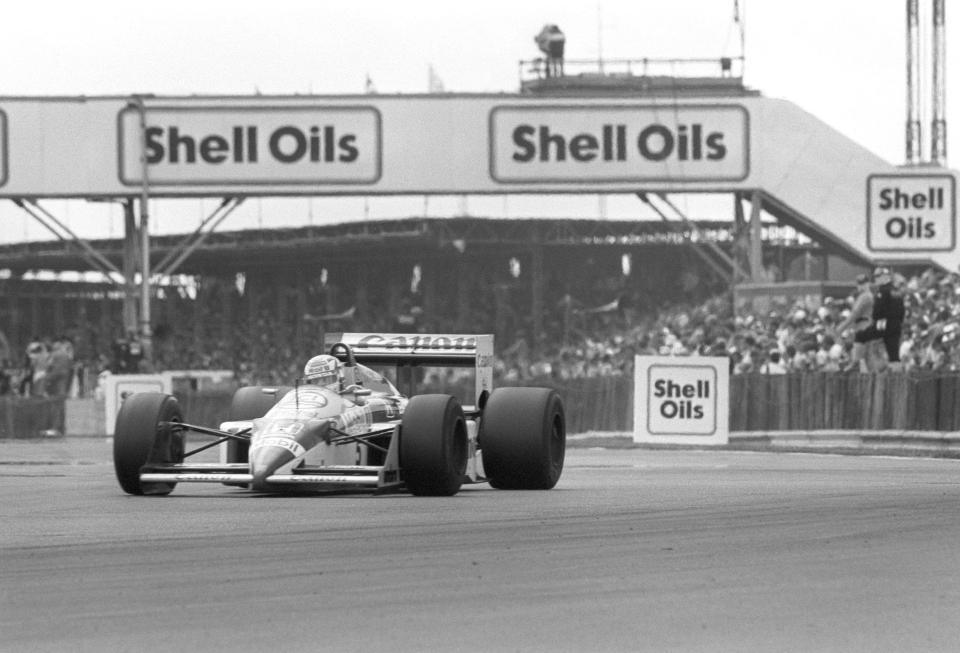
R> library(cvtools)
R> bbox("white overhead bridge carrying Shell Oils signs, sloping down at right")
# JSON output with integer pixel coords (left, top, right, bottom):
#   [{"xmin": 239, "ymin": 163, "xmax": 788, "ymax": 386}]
[{"xmin": 0, "ymin": 94, "xmax": 957, "ymax": 266}]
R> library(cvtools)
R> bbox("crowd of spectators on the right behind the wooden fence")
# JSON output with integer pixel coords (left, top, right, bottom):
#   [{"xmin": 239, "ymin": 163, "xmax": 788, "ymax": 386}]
[{"xmin": 510, "ymin": 269, "xmax": 960, "ymax": 379}]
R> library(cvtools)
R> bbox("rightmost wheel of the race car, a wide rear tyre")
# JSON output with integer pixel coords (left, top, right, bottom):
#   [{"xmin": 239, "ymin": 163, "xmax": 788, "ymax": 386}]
[{"xmin": 478, "ymin": 388, "xmax": 567, "ymax": 490}]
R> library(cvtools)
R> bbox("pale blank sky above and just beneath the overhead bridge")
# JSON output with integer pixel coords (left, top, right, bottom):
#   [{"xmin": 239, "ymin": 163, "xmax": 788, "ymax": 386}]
[{"xmin": 0, "ymin": 0, "xmax": 960, "ymax": 242}]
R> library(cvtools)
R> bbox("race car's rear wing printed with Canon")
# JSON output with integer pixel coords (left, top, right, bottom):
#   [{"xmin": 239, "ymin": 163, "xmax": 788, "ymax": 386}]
[{"xmin": 324, "ymin": 333, "xmax": 493, "ymax": 400}]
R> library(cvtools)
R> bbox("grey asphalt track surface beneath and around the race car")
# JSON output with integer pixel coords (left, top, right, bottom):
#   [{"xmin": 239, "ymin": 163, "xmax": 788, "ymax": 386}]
[{"xmin": 0, "ymin": 440, "xmax": 960, "ymax": 652}]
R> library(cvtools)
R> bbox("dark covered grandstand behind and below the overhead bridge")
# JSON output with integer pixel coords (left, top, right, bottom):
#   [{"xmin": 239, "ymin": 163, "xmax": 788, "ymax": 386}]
[{"xmin": 0, "ymin": 209, "xmax": 848, "ymax": 382}]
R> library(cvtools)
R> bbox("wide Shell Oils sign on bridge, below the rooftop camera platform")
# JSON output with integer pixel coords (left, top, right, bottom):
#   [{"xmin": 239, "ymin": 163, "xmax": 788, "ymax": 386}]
[{"xmin": 490, "ymin": 105, "xmax": 750, "ymax": 184}]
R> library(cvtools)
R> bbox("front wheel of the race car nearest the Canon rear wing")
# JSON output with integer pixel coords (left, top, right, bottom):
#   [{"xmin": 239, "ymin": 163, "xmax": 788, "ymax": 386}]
[{"xmin": 400, "ymin": 395, "xmax": 467, "ymax": 496}]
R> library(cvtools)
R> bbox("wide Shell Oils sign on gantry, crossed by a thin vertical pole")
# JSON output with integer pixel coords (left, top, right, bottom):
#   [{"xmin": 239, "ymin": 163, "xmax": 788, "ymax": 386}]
[{"xmin": 118, "ymin": 106, "xmax": 382, "ymax": 186}]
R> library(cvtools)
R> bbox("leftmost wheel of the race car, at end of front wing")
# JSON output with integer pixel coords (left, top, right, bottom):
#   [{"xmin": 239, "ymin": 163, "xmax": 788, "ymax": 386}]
[{"xmin": 113, "ymin": 392, "xmax": 184, "ymax": 495}]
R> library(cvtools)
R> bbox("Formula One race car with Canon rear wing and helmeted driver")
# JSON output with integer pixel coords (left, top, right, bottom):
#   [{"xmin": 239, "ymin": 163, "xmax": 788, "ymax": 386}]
[{"xmin": 113, "ymin": 333, "xmax": 566, "ymax": 496}]
